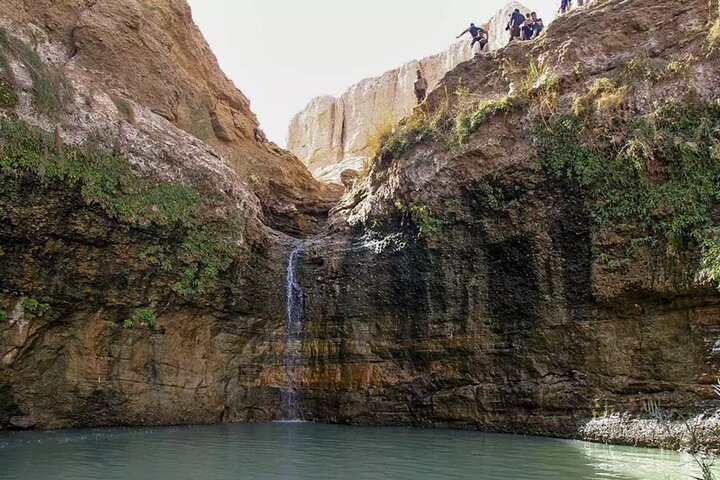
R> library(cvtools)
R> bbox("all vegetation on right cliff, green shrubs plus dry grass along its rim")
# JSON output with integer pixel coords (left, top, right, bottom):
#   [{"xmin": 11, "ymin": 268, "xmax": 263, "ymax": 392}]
[{"xmin": 366, "ymin": 47, "xmax": 720, "ymax": 286}]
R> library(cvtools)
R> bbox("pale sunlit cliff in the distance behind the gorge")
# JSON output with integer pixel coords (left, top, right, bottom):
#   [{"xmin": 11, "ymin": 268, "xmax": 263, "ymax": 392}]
[{"xmin": 287, "ymin": 1, "xmax": 530, "ymax": 181}]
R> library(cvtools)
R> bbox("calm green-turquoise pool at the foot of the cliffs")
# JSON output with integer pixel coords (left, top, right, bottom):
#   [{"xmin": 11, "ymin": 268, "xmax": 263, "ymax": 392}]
[{"xmin": 0, "ymin": 423, "xmax": 716, "ymax": 480}]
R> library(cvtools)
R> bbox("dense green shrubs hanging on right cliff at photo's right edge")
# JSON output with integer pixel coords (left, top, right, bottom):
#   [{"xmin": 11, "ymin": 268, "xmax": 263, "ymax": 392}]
[{"xmin": 534, "ymin": 102, "xmax": 720, "ymax": 285}]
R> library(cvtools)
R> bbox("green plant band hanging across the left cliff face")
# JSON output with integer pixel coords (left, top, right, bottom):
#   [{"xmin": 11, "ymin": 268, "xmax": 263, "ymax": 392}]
[{"xmin": 0, "ymin": 118, "xmax": 241, "ymax": 299}]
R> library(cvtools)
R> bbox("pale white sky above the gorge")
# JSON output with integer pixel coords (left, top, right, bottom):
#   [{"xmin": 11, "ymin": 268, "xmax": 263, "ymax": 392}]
[{"xmin": 189, "ymin": 0, "xmax": 560, "ymax": 147}]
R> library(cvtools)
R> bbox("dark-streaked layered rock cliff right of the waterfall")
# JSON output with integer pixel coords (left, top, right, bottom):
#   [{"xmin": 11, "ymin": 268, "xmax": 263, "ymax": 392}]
[{"xmin": 286, "ymin": 0, "xmax": 720, "ymax": 448}]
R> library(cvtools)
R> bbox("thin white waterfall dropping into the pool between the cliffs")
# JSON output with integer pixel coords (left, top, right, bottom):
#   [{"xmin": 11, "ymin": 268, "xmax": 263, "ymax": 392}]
[{"xmin": 280, "ymin": 242, "xmax": 305, "ymax": 420}]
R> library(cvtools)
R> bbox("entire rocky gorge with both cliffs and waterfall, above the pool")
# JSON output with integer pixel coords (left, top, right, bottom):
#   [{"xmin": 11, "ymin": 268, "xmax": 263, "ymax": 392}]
[{"xmin": 0, "ymin": 0, "xmax": 720, "ymax": 458}]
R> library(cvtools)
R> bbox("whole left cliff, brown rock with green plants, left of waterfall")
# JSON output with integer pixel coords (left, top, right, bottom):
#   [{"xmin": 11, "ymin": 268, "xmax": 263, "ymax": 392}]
[{"xmin": 0, "ymin": 0, "xmax": 338, "ymax": 429}]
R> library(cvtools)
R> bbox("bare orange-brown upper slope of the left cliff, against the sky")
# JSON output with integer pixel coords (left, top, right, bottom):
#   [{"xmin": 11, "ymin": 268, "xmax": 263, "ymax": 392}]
[{"xmin": 2, "ymin": 0, "xmax": 338, "ymax": 233}]
